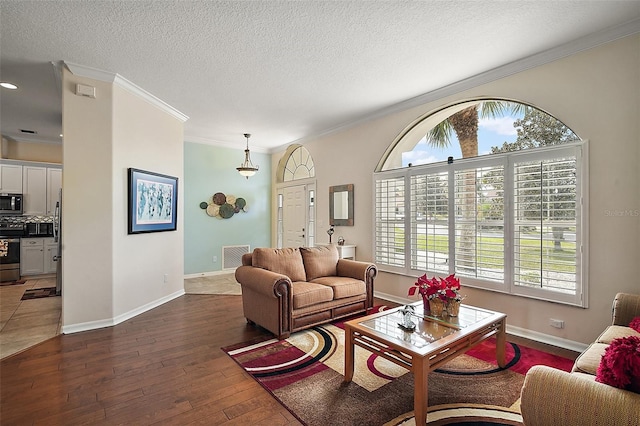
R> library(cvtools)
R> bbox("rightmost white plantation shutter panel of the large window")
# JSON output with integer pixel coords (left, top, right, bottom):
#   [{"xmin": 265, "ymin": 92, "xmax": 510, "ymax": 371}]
[{"xmin": 513, "ymin": 148, "xmax": 580, "ymax": 295}]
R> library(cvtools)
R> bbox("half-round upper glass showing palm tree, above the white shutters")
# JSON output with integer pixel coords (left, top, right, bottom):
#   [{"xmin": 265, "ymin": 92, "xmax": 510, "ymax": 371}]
[{"xmin": 378, "ymin": 99, "xmax": 579, "ymax": 170}]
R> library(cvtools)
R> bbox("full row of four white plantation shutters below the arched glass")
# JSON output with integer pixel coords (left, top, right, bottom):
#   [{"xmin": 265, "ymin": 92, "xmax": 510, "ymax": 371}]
[{"xmin": 374, "ymin": 142, "xmax": 588, "ymax": 306}]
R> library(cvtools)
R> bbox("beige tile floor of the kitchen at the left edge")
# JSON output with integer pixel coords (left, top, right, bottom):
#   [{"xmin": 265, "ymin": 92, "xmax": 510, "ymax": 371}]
[{"xmin": 0, "ymin": 277, "xmax": 62, "ymax": 358}]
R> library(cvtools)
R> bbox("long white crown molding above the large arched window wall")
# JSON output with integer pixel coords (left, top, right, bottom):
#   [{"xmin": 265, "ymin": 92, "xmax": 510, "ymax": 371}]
[{"xmin": 284, "ymin": 19, "xmax": 640, "ymax": 152}]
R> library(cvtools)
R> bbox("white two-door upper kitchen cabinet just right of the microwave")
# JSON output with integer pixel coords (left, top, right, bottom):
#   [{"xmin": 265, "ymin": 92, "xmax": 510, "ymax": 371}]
[{"xmin": 22, "ymin": 165, "xmax": 62, "ymax": 216}]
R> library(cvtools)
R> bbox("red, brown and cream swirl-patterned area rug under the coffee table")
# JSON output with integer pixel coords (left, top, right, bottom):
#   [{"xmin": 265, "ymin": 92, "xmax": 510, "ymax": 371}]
[{"xmin": 222, "ymin": 310, "xmax": 573, "ymax": 426}]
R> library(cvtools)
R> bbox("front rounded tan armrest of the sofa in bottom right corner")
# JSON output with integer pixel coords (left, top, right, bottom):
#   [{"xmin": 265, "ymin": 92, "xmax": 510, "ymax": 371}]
[{"xmin": 520, "ymin": 365, "xmax": 640, "ymax": 426}]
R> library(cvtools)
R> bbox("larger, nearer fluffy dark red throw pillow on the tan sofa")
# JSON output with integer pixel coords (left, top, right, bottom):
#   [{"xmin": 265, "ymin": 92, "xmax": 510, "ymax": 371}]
[{"xmin": 596, "ymin": 336, "xmax": 640, "ymax": 393}]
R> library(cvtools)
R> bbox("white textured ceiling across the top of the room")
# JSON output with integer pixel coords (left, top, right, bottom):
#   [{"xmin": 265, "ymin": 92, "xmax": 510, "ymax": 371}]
[{"xmin": 0, "ymin": 0, "xmax": 640, "ymax": 150}]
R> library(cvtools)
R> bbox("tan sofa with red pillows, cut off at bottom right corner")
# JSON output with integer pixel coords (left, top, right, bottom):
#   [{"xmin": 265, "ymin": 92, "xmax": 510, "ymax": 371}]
[{"xmin": 520, "ymin": 293, "xmax": 640, "ymax": 426}]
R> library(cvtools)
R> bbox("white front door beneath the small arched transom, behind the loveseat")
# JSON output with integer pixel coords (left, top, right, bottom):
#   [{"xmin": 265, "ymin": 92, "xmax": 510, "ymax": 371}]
[{"xmin": 282, "ymin": 185, "xmax": 307, "ymax": 247}]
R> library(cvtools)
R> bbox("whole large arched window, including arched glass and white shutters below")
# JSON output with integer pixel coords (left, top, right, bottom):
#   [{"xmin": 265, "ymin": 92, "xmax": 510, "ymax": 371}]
[{"xmin": 374, "ymin": 99, "xmax": 587, "ymax": 306}]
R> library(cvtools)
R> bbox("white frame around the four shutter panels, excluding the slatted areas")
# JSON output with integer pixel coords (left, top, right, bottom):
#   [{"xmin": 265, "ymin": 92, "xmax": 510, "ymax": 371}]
[{"xmin": 373, "ymin": 141, "xmax": 589, "ymax": 308}]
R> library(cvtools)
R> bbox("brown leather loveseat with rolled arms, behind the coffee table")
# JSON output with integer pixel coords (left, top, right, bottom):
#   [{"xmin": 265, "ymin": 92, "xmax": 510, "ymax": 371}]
[{"xmin": 235, "ymin": 245, "xmax": 377, "ymax": 339}]
